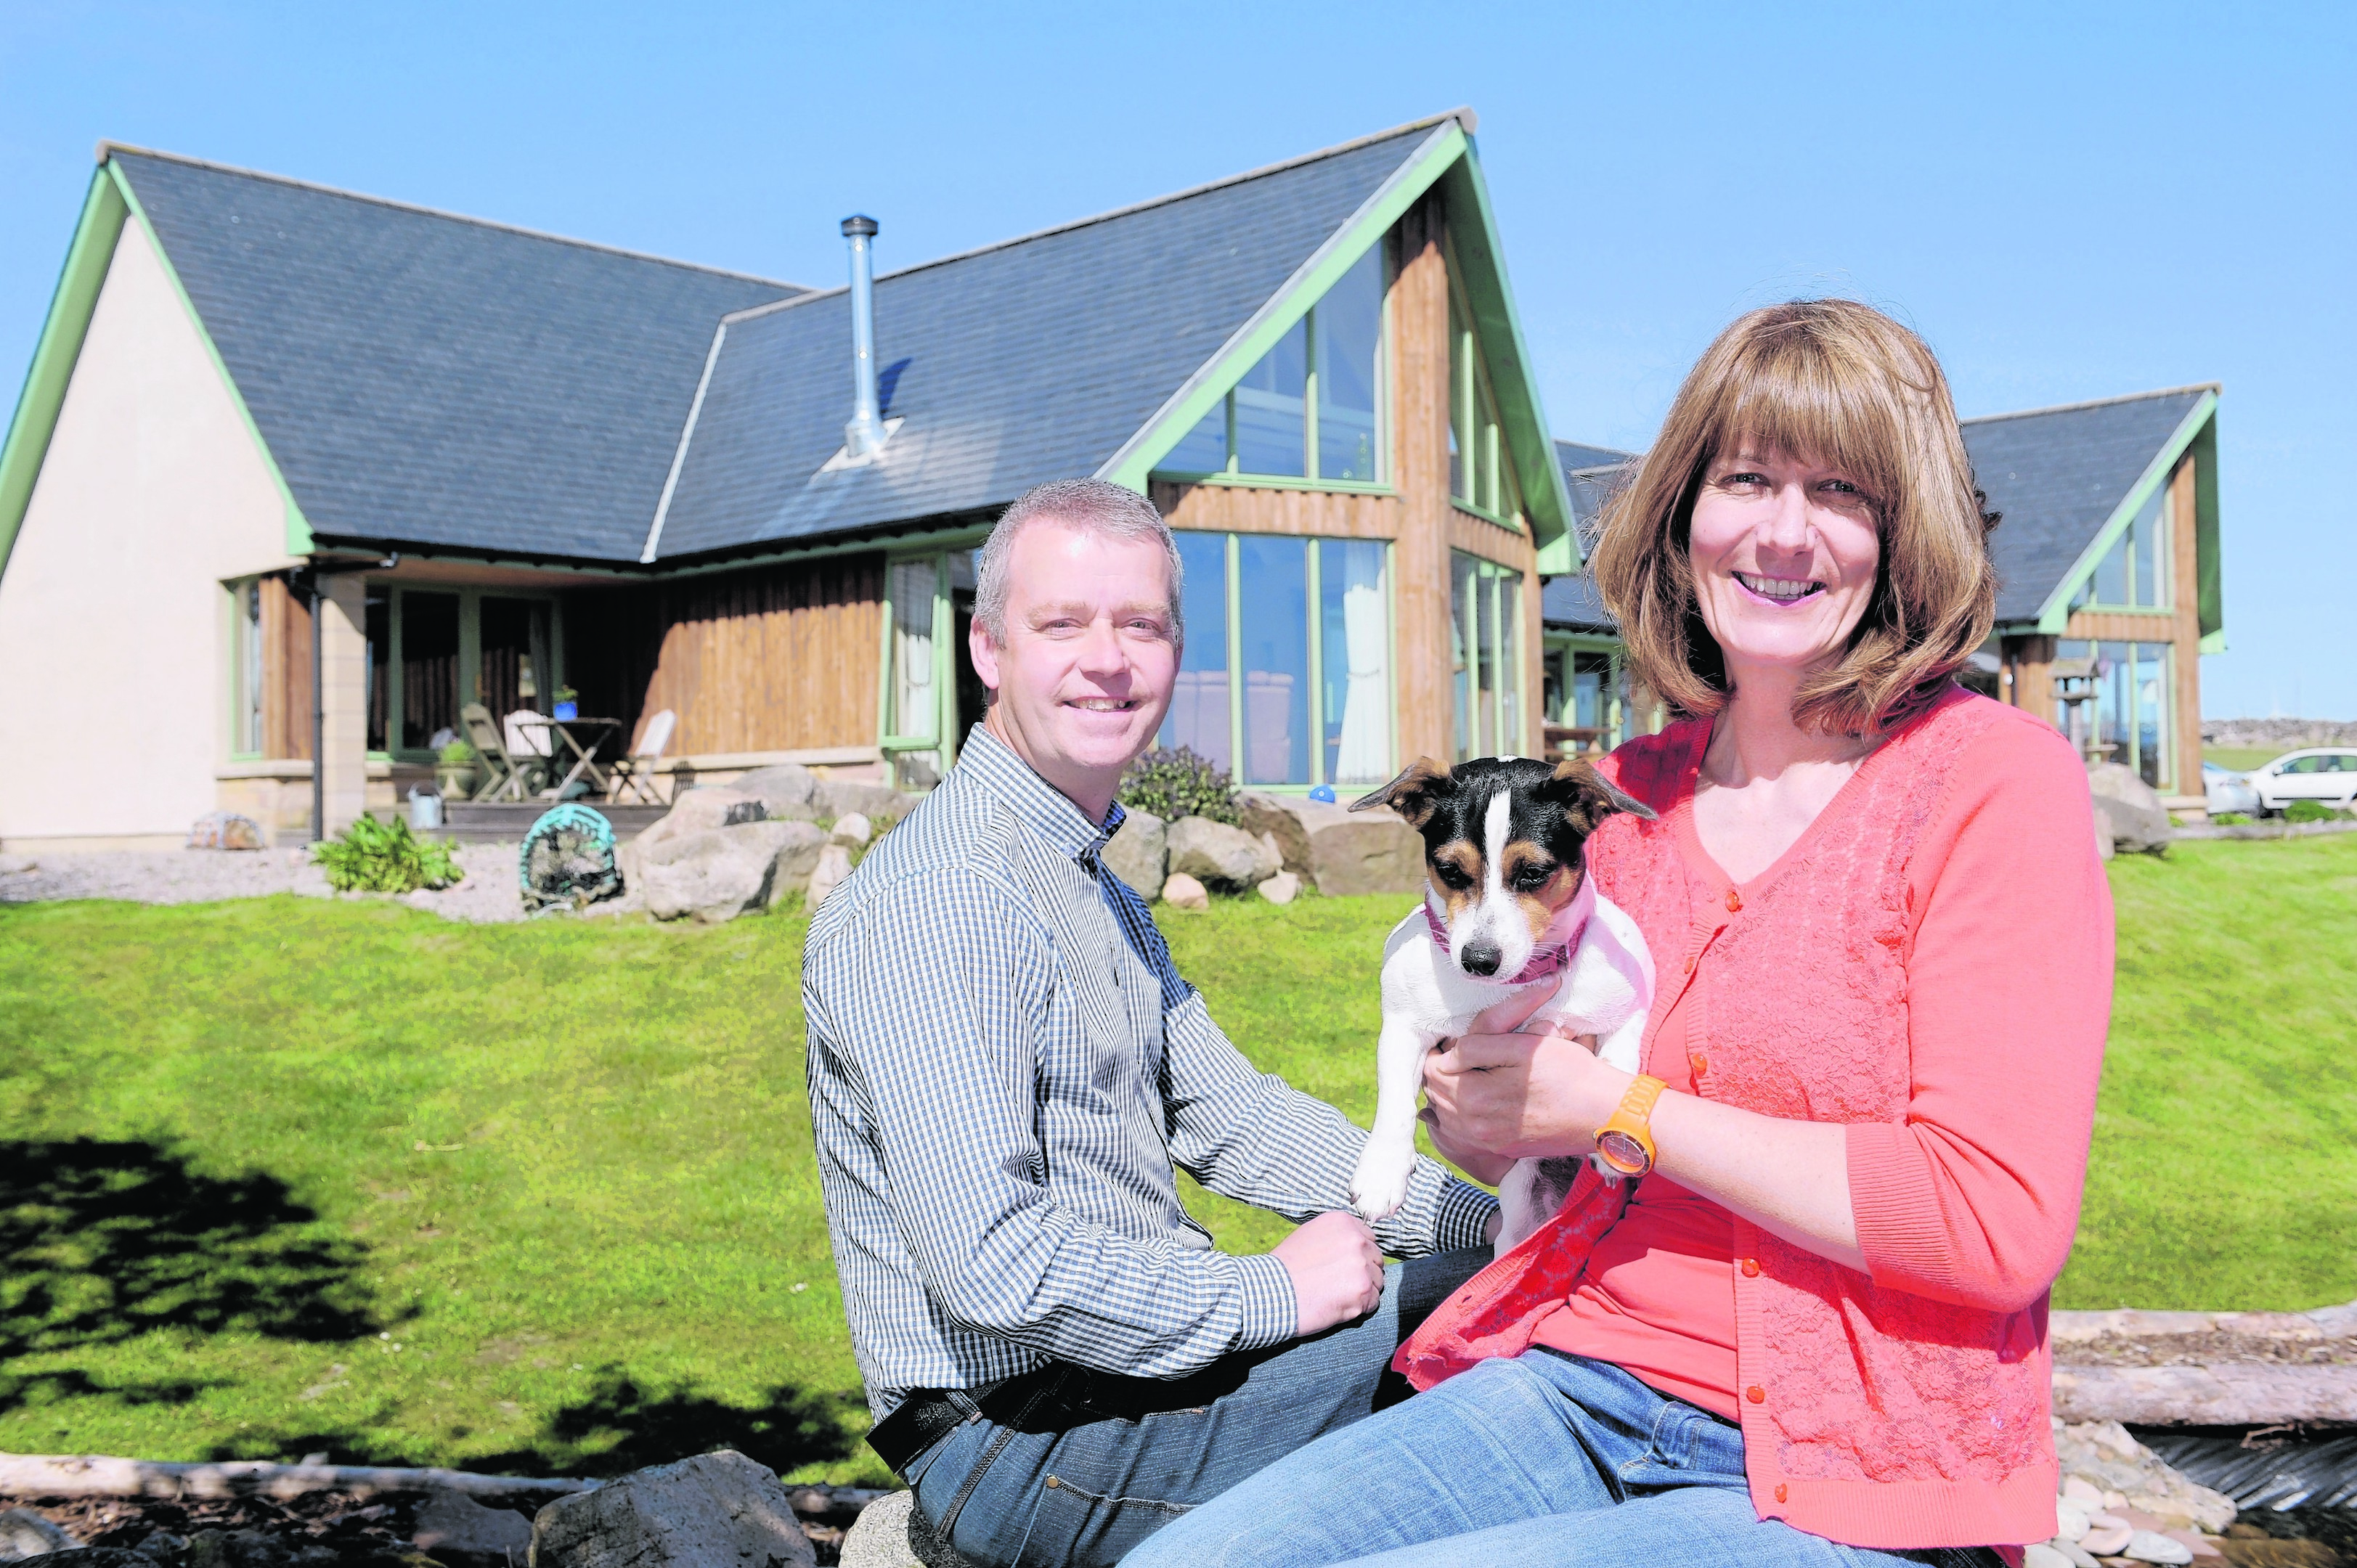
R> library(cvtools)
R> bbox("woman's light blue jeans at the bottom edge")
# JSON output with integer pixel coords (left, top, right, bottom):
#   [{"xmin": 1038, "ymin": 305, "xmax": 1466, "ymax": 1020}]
[{"xmin": 1122, "ymin": 1349, "xmax": 1996, "ymax": 1568}]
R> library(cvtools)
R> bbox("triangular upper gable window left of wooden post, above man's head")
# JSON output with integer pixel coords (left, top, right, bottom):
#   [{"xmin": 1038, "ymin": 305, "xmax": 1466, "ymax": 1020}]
[{"xmin": 1157, "ymin": 245, "xmax": 1383, "ymax": 483}]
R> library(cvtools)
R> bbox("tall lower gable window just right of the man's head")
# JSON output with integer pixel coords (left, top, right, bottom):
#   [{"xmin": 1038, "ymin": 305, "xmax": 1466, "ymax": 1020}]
[{"xmin": 1160, "ymin": 533, "xmax": 1393, "ymax": 785}]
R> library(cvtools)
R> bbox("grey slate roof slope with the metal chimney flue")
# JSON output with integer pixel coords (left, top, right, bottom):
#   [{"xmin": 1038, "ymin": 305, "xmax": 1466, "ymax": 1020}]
[{"xmin": 658, "ymin": 121, "xmax": 1445, "ymax": 561}]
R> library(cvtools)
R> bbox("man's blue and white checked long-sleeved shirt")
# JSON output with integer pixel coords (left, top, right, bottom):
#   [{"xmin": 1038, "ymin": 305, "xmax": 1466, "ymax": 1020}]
[{"xmin": 802, "ymin": 726, "xmax": 1497, "ymax": 1419}]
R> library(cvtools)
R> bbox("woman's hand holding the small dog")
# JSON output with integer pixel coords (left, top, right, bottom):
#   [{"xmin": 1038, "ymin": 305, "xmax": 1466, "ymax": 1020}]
[{"xmin": 1424, "ymin": 990, "xmax": 1629, "ymax": 1160}]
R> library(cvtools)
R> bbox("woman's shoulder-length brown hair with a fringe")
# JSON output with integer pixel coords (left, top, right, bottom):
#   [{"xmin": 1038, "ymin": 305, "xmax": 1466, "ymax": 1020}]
[{"xmin": 1593, "ymin": 300, "xmax": 1996, "ymax": 735}]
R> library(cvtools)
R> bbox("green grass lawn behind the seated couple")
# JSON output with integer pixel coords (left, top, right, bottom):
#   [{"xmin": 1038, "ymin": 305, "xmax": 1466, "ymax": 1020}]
[{"xmin": 0, "ymin": 837, "xmax": 2357, "ymax": 1481}]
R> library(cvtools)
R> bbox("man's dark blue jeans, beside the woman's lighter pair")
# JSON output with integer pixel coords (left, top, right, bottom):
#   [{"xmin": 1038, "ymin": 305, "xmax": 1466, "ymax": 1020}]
[{"xmin": 908, "ymin": 1247, "xmax": 1489, "ymax": 1568}]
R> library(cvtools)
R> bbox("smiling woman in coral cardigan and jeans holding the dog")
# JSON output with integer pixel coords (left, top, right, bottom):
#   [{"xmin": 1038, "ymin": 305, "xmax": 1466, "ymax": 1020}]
[{"xmin": 1129, "ymin": 300, "xmax": 2112, "ymax": 1568}]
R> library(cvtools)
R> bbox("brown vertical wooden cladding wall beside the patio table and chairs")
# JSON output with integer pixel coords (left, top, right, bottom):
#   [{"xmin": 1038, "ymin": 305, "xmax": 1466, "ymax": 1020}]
[{"xmin": 566, "ymin": 554, "xmax": 884, "ymax": 757}]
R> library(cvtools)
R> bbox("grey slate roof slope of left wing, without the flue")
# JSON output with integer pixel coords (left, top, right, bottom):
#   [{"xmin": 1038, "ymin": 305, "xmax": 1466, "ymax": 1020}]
[{"xmin": 113, "ymin": 149, "xmax": 804, "ymax": 561}]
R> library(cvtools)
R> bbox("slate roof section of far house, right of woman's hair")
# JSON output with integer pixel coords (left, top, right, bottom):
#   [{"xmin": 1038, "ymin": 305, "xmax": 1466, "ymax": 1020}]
[{"xmin": 1963, "ymin": 387, "xmax": 2213, "ymax": 625}]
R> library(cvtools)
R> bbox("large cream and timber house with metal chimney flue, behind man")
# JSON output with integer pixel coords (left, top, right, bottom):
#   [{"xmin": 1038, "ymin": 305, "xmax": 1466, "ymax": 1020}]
[{"xmin": 0, "ymin": 111, "xmax": 1579, "ymax": 849}]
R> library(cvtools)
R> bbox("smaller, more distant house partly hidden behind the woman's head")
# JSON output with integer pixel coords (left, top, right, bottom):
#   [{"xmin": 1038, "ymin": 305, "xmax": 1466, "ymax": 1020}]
[{"xmin": 1542, "ymin": 387, "xmax": 2225, "ymax": 811}]
